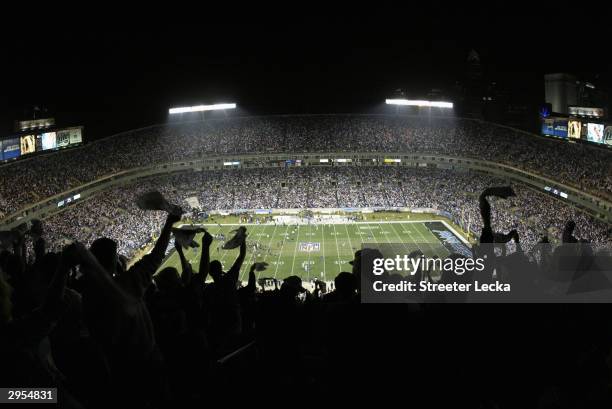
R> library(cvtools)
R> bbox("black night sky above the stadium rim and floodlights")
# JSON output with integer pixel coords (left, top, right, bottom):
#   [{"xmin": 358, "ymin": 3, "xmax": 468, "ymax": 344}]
[{"xmin": 0, "ymin": 7, "xmax": 612, "ymax": 137}]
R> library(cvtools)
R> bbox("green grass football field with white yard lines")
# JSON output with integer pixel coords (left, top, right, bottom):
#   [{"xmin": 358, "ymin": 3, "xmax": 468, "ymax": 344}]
[{"xmin": 161, "ymin": 214, "xmax": 468, "ymax": 281}]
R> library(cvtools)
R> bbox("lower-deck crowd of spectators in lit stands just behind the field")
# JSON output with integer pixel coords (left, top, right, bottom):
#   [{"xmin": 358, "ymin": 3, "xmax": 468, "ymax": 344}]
[{"xmin": 39, "ymin": 167, "xmax": 611, "ymax": 258}]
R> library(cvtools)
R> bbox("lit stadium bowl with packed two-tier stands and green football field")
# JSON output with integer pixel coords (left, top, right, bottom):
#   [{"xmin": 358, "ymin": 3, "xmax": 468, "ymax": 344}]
[{"xmin": 2, "ymin": 115, "xmax": 612, "ymax": 284}]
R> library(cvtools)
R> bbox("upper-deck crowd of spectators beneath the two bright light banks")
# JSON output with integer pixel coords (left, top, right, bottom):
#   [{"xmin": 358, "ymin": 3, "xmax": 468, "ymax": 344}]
[{"xmin": 0, "ymin": 115, "xmax": 612, "ymax": 215}]
